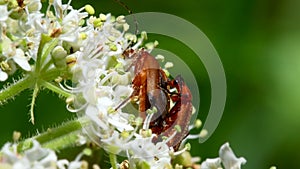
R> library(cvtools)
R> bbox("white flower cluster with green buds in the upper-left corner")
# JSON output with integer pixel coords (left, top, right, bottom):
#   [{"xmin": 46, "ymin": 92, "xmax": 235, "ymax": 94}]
[{"xmin": 0, "ymin": 0, "xmax": 101, "ymax": 81}]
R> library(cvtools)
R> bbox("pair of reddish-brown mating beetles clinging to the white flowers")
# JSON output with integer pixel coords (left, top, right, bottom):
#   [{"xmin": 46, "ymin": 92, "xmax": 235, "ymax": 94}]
[{"xmin": 118, "ymin": 49, "xmax": 193, "ymax": 149}]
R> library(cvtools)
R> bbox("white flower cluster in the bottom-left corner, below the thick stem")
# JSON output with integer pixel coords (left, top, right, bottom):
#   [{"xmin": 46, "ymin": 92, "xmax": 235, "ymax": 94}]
[{"xmin": 0, "ymin": 140, "xmax": 84, "ymax": 169}]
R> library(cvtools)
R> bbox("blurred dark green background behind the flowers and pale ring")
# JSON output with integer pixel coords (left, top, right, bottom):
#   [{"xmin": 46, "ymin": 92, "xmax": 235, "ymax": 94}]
[{"xmin": 0, "ymin": 0, "xmax": 300, "ymax": 169}]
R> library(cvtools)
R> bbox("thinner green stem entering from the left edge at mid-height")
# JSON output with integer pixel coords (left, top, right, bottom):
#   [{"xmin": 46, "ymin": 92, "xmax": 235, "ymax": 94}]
[{"xmin": 0, "ymin": 76, "xmax": 35, "ymax": 103}]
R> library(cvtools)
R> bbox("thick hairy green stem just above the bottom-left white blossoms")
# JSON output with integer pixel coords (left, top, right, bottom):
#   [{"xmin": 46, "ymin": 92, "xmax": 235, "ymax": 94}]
[{"xmin": 18, "ymin": 117, "xmax": 90, "ymax": 152}]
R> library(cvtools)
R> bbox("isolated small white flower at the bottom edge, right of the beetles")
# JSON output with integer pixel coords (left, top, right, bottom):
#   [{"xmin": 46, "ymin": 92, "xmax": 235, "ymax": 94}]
[{"xmin": 219, "ymin": 143, "xmax": 247, "ymax": 169}]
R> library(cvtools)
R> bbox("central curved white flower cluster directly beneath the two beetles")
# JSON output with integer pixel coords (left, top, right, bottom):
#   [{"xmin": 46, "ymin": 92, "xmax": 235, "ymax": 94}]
[{"xmin": 67, "ymin": 6, "xmax": 172, "ymax": 168}]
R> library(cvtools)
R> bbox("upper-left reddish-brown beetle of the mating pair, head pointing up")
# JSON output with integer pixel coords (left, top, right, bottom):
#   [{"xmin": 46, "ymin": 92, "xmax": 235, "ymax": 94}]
[{"xmin": 127, "ymin": 49, "xmax": 170, "ymax": 119}]
